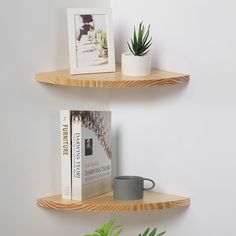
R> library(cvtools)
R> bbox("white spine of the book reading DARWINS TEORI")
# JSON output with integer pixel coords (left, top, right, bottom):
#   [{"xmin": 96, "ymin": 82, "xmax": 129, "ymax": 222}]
[{"xmin": 71, "ymin": 114, "xmax": 82, "ymax": 201}]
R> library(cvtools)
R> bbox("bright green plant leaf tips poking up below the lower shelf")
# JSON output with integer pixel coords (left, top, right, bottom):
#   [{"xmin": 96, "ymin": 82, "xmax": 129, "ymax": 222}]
[{"xmin": 85, "ymin": 218, "xmax": 166, "ymax": 236}]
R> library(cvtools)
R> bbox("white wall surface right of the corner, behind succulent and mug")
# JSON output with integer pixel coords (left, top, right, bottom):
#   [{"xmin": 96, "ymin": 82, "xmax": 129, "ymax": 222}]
[{"xmin": 111, "ymin": 0, "xmax": 236, "ymax": 236}]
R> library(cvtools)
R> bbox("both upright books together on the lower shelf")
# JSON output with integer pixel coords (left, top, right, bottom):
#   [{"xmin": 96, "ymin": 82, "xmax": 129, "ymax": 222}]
[{"xmin": 60, "ymin": 110, "xmax": 112, "ymax": 201}]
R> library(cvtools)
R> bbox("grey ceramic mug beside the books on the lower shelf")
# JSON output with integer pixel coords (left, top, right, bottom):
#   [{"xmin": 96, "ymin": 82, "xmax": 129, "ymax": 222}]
[{"xmin": 113, "ymin": 175, "xmax": 155, "ymax": 200}]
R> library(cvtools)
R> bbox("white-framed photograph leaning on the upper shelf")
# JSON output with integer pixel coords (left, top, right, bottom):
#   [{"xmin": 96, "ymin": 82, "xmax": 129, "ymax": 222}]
[{"xmin": 67, "ymin": 8, "xmax": 115, "ymax": 74}]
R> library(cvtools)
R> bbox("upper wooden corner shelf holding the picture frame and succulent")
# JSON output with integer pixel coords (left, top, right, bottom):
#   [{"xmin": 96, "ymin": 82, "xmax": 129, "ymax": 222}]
[{"xmin": 36, "ymin": 65, "xmax": 189, "ymax": 88}]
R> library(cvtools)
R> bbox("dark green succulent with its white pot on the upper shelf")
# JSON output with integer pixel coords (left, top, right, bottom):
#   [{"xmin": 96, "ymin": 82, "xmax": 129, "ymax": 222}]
[{"xmin": 121, "ymin": 22, "xmax": 152, "ymax": 76}]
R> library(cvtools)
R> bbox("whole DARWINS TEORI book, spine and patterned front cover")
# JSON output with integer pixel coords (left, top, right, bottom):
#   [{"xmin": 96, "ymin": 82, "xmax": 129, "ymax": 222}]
[{"xmin": 70, "ymin": 111, "xmax": 112, "ymax": 201}]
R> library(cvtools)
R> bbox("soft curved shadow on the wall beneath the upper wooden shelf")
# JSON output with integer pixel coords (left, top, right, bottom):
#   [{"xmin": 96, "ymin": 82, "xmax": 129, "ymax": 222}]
[{"xmin": 36, "ymin": 79, "xmax": 187, "ymax": 104}]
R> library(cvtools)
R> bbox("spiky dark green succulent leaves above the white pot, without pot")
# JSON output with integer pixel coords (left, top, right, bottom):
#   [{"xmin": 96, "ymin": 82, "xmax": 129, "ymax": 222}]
[{"xmin": 127, "ymin": 22, "xmax": 152, "ymax": 56}]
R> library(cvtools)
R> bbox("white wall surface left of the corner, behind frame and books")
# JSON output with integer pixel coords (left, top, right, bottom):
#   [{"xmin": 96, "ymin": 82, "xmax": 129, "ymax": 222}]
[{"xmin": 0, "ymin": 0, "xmax": 113, "ymax": 236}]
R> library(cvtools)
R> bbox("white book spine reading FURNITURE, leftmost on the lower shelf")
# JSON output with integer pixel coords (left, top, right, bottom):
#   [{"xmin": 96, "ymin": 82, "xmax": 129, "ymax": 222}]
[{"xmin": 60, "ymin": 110, "xmax": 72, "ymax": 199}]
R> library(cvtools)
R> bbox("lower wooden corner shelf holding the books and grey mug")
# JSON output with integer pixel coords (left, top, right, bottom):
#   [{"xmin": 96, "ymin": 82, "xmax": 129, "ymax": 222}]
[{"xmin": 37, "ymin": 191, "xmax": 190, "ymax": 212}]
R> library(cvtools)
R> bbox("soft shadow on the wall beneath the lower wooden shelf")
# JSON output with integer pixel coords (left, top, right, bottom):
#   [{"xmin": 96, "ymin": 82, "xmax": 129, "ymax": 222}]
[{"xmin": 38, "ymin": 207, "xmax": 189, "ymax": 235}]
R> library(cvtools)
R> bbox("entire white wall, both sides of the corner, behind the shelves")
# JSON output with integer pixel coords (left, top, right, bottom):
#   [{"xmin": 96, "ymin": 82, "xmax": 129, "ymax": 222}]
[{"xmin": 0, "ymin": 0, "xmax": 236, "ymax": 236}]
